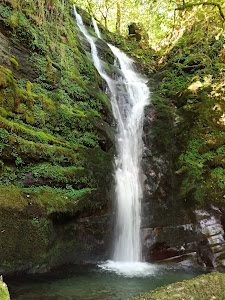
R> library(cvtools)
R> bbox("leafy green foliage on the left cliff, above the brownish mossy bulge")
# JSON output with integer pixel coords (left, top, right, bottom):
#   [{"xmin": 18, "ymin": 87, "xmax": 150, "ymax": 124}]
[{"xmin": 0, "ymin": 0, "xmax": 111, "ymax": 227}]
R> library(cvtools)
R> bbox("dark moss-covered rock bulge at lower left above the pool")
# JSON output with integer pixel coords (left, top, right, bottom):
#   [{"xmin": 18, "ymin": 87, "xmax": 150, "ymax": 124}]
[{"xmin": 0, "ymin": 186, "xmax": 113, "ymax": 273}]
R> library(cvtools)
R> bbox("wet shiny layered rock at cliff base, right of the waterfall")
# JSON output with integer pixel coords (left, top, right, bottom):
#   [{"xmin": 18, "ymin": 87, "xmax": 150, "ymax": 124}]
[{"xmin": 142, "ymin": 190, "xmax": 225, "ymax": 270}]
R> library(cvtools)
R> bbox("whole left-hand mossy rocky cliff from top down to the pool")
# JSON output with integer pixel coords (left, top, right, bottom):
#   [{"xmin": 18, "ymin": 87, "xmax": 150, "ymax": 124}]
[{"xmin": 0, "ymin": 0, "xmax": 114, "ymax": 273}]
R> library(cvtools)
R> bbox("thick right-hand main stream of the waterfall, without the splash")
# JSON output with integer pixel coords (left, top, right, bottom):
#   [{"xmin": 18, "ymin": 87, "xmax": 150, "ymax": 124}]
[{"xmin": 110, "ymin": 45, "xmax": 149, "ymax": 262}]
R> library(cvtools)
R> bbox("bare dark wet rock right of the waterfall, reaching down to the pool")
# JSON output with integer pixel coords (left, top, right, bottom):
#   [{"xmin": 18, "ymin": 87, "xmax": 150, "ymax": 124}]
[{"xmin": 141, "ymin": 102, "xmax": 225, "ymax": 270}]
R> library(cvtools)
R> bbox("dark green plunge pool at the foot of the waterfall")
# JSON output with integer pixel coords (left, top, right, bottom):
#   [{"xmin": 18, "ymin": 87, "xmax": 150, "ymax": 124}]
[{"xmin": 5, "ymin": 261, "xmax": 204, "ymax": 300}]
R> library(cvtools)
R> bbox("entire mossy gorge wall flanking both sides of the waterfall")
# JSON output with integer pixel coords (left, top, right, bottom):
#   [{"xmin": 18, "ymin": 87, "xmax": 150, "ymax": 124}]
[{"xmin": 0, "ymin": 0, "xmax": 225, "ymax": 273}]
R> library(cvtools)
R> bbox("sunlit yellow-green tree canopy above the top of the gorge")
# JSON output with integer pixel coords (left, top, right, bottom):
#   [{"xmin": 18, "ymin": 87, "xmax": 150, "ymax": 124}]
[{"xmin": 74, "ymin": 0, "xmax": 225, "ymax": 47}]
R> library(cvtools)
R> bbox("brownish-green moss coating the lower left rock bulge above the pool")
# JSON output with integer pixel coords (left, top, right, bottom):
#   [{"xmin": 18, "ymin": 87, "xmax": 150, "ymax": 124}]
[{"xmin": 0, "ymin": 186, "xmax": 96, "ymax": 271}]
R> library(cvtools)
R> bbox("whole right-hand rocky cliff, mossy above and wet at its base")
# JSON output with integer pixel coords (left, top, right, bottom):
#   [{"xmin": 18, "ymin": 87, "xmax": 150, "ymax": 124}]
[{"xmin": 139, "ymin": 23, "xmax": 225, "ymax": 270}]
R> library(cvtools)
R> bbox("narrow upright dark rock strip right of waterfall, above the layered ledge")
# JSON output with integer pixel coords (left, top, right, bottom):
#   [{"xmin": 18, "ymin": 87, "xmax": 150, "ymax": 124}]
[{"xmin": 142, "ymin": 106, "xmax": 177, "ymax": 227}]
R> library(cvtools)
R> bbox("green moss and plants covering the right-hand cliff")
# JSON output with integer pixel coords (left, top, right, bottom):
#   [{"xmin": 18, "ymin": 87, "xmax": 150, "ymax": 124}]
[{"xmin": 153, "ymin": 23, "xmax": 225, "ymax": 207}]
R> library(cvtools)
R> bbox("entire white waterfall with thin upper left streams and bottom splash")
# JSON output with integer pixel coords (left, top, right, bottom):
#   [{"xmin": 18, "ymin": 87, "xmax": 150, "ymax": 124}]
[{"xmin": 74, "ymin": 6, "xmax": 153, "ymax": 275}]
